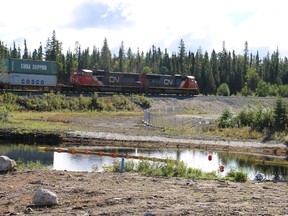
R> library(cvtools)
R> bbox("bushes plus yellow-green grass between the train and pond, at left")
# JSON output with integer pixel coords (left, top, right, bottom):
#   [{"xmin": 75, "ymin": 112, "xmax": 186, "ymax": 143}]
[{"xmin": 0, "ymin": 93, "xmax": 151, "ymax": 134}]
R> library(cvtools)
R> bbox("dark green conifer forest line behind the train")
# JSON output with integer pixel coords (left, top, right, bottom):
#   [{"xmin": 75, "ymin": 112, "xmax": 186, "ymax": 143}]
[{"xmin": 0, "ymin": 31, "xmax": 288, "ymax": 97}]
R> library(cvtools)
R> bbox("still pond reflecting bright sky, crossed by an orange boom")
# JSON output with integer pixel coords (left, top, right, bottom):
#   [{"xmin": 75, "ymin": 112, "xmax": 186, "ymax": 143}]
[{"xmin": 0, "ymin": 144, "xmax": 288, "ymax": 180}]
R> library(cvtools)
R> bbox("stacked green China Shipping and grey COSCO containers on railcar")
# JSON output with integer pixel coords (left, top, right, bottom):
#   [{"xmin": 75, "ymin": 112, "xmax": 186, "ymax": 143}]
[{"xmin": 0, "ymin": 59, "xmax": 57, "ymax": 91}]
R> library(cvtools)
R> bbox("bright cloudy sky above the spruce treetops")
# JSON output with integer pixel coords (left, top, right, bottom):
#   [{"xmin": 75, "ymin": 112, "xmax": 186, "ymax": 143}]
[{"xmin": 0, "ymin": 0, "xmax": 288, "ymax": 56}]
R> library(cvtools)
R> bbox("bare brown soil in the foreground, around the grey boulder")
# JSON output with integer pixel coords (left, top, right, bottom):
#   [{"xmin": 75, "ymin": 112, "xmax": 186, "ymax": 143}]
[{"xmin": 0, "ymin": 171, "xmax": 288, "ymax": 216}]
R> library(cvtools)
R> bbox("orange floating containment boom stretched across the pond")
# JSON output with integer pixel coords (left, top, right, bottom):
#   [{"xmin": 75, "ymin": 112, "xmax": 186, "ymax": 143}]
[{"xmin": 38, "ymin": 147, "xmax": 171, "ymax": 162}]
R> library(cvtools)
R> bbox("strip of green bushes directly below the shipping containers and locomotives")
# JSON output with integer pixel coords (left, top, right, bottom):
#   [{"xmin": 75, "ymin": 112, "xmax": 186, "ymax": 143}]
[{"xmin": 0, "ymin": 93, "xmax": 151, "ymax": 112}]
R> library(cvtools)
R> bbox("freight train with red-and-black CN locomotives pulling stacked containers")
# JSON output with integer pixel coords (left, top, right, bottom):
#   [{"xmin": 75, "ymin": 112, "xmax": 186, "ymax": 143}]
[{"xmin": 0, "ymin": 59, "xmax": 199, "ymax": 96}]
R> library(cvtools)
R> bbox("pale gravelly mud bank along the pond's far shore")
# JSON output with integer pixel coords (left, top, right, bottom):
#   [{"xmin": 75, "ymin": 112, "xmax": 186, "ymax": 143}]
[{"xmin": 63, "ymin": 131, "xmax": 288, "ymax": 157}]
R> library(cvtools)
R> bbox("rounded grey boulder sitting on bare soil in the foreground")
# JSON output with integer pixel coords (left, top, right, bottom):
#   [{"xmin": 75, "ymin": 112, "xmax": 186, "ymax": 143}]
[{"xmin": 33, "ymin": 188, "xmax": 58, "ymax": 206}]
